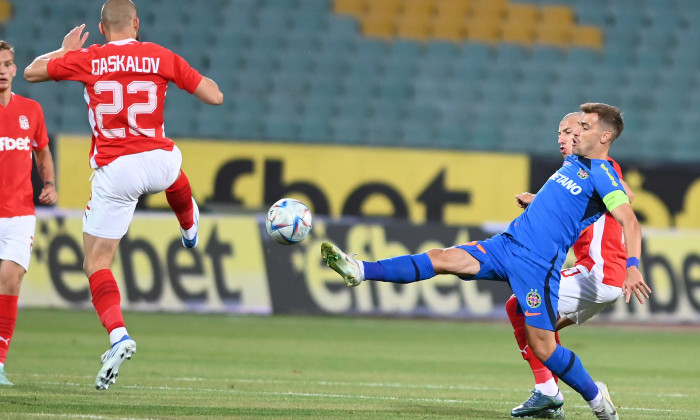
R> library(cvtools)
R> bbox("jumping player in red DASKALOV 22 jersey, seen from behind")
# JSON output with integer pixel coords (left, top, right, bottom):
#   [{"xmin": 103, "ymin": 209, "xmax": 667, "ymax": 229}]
[{"xmin": 24, "ymin": 0, "xmax": 223, "ymax": 390}]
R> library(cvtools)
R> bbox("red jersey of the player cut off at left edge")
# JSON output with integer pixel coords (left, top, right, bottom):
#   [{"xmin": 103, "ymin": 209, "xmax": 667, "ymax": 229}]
[{"xmin": 0, "ymin": 93, "xmax": 49, "ymax": 217}]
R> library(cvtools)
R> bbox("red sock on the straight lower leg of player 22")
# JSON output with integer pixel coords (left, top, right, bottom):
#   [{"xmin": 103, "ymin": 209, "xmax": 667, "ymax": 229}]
[{"xmin": 90, "ymin": 269, "xmax": 125, "ymax": 333}]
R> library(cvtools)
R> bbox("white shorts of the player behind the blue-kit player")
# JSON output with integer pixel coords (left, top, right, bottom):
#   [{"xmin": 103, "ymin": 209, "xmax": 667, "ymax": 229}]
[{"xmin": 559, "ymin": 265, "xmax": 622, "ymax": 324}]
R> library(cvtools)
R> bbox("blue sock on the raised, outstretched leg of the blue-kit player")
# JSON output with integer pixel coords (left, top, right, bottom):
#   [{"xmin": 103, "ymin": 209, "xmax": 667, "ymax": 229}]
[{"xmin": 362, "ymin": 253, "xmax": 435, "ymax": 283}]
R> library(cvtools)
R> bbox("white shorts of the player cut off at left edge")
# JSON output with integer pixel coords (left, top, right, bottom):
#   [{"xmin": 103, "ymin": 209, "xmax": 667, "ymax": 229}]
[{"xmin": 0, "ymin": 216, "xmax": 36, "ymax": 271}]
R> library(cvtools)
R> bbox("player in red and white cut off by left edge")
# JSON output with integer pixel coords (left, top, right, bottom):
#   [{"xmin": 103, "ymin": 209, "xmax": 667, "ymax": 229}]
[{"xmin": 0, "ymin": 40, "xmax": 58, "ymax": 385}]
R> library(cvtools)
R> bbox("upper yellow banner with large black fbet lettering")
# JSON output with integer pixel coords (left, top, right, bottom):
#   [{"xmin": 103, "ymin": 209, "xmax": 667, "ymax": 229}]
[{"xmin": 57, "ymin": 136, "xmax": 530, "ymax": 225}]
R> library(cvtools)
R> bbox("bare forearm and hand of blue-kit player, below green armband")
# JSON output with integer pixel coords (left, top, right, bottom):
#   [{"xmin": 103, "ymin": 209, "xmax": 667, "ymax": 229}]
[{"xmin": 606, "ymin": 199, "xmax": 651, "ymax": 304}]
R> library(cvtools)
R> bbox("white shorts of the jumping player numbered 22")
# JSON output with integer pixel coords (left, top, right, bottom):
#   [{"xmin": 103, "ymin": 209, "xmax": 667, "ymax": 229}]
[{"xmin": 83, "ymin": 146, "xmax": 182, "ymax": 239}]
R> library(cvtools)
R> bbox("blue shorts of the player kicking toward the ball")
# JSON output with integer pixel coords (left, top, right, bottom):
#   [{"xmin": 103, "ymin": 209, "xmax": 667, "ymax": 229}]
[{"xmin": 456, "ymin": 233, "xmax": 566, "ymax": 331}]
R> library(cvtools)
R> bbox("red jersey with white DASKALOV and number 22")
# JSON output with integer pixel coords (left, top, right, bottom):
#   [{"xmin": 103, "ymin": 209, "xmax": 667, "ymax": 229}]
[{"xmin": 47, "ymin": 39, "xmax": 202, "ymax": 168}]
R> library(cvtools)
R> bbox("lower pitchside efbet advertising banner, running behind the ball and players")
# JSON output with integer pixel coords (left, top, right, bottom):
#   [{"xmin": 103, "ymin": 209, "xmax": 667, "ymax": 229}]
[{"xmin": 20, "ymin": 212, "xmax": 700, "ymax": 324}]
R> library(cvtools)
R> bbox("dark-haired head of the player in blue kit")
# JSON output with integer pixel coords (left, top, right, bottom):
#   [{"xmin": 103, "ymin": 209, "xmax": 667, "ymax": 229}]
[{"xmin": 572, "ymin": 103, "xmax": 625, "ymax": 157}]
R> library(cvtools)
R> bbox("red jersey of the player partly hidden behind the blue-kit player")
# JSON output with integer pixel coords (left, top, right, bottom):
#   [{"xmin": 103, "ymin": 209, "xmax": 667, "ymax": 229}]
[{"xmin": 574, "ymin": 159, "xmax": 627, "ymax": 287}]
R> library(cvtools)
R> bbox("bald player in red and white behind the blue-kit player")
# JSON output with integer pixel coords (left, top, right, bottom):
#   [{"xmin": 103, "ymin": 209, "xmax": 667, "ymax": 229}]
[{"xmin": 506, "ymin": 112, "xmax": 634, "ymax": 418}]
